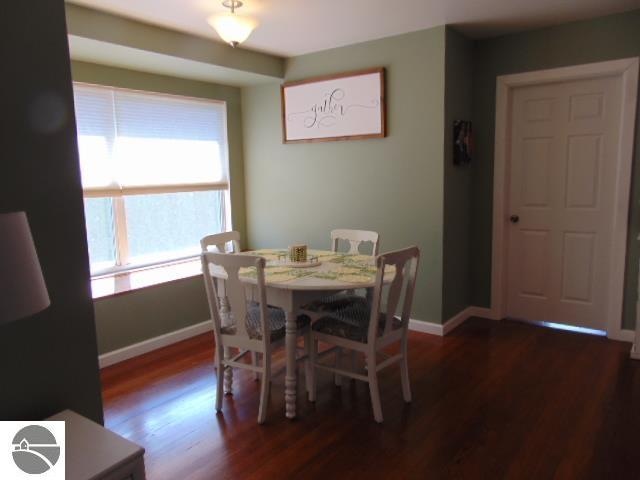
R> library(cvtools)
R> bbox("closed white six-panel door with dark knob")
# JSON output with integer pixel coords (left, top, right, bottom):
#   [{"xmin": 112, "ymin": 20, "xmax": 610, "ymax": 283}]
[{"xmin": 506, "ymin": 76, "xmax": 621, "ymax": 330}]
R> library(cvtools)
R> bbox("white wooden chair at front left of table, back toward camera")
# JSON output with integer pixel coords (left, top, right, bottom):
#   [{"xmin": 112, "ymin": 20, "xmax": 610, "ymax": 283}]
[{"xmin": 201, "ymin": 252, "xmax": 311, "ymax": 423}]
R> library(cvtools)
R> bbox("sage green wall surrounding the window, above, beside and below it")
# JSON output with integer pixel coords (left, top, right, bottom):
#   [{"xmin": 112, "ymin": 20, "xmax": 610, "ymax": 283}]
[{"xmin": 72, "ymin": 62, "xmax": 246, "ymax": 354}]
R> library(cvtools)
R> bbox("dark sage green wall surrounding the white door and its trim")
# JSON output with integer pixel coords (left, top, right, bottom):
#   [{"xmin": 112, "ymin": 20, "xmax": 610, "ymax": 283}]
[{"xmin": 471, "ymin": 10, "xmax": 640, "ymax": 328}]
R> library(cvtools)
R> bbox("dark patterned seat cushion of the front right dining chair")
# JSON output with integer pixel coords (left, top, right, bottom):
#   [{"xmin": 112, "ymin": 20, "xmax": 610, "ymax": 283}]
[{"xmin": 311, "ymin": 305, "xmax": 402, "ymax": 343}]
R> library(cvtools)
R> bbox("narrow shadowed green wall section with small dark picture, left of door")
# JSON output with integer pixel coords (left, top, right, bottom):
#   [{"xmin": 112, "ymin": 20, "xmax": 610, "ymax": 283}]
[{"xmin": 442, "ymin": 27, "xmax": 473, "ymax": 321}]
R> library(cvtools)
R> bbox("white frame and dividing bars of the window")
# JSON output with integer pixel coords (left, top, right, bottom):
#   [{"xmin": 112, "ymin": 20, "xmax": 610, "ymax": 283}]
[{"xmin": 73, "ymin": 81, "xmax": 233, "ymax": 279}]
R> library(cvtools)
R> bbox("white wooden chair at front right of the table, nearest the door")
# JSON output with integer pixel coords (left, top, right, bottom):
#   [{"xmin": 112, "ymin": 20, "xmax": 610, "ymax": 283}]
[{"xmin": 309, "ymin": 247, "xmax": 420, "ymax": 422}]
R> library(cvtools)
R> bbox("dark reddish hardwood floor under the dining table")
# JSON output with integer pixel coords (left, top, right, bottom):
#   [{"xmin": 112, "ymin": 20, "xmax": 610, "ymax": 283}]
[{"xmin": 102, "ymin": 319, "xmax": 640, "ymax": 480}]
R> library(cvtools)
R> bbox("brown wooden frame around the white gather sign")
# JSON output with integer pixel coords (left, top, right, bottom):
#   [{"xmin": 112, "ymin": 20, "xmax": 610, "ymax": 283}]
[{"xmin": 280, "ymin": 67, "xmax": 387, "ymax": 143}]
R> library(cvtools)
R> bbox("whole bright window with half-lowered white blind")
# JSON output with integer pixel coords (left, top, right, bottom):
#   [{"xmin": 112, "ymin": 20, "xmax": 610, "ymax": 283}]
[{"xmin": 73, "ymin": 83, "xmax": 231, "ymax": 276}]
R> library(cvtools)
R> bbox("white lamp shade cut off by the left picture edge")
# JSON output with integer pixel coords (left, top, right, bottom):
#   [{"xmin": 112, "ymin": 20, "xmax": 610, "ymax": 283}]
[{"xmin": 0, "ymin": 212, "xmax": 49, "ymax": 324}]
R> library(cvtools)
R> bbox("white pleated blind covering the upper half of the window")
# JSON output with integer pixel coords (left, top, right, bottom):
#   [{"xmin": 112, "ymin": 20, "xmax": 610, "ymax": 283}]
[{"xmin": 74, "ymin": 83, "xmax": 229, "ymax": 197}]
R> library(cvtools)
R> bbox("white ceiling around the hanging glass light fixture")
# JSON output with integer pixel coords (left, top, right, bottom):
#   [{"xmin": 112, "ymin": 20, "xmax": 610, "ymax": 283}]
[{"xmin": 70, "ymin": 0, "xmax": 640, "ymax": 56}]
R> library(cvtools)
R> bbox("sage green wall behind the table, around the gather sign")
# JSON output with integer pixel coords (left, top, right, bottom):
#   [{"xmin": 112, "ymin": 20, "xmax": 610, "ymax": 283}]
[{"xmin": 242, "ymin": 27, "xmax": 445, "ymax": 323}]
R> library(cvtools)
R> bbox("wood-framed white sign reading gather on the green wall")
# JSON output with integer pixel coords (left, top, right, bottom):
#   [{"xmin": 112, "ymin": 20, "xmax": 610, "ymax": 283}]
[{"xmin": 281, "ymin": 68, "xmax": 386, "ymax": 143}]
